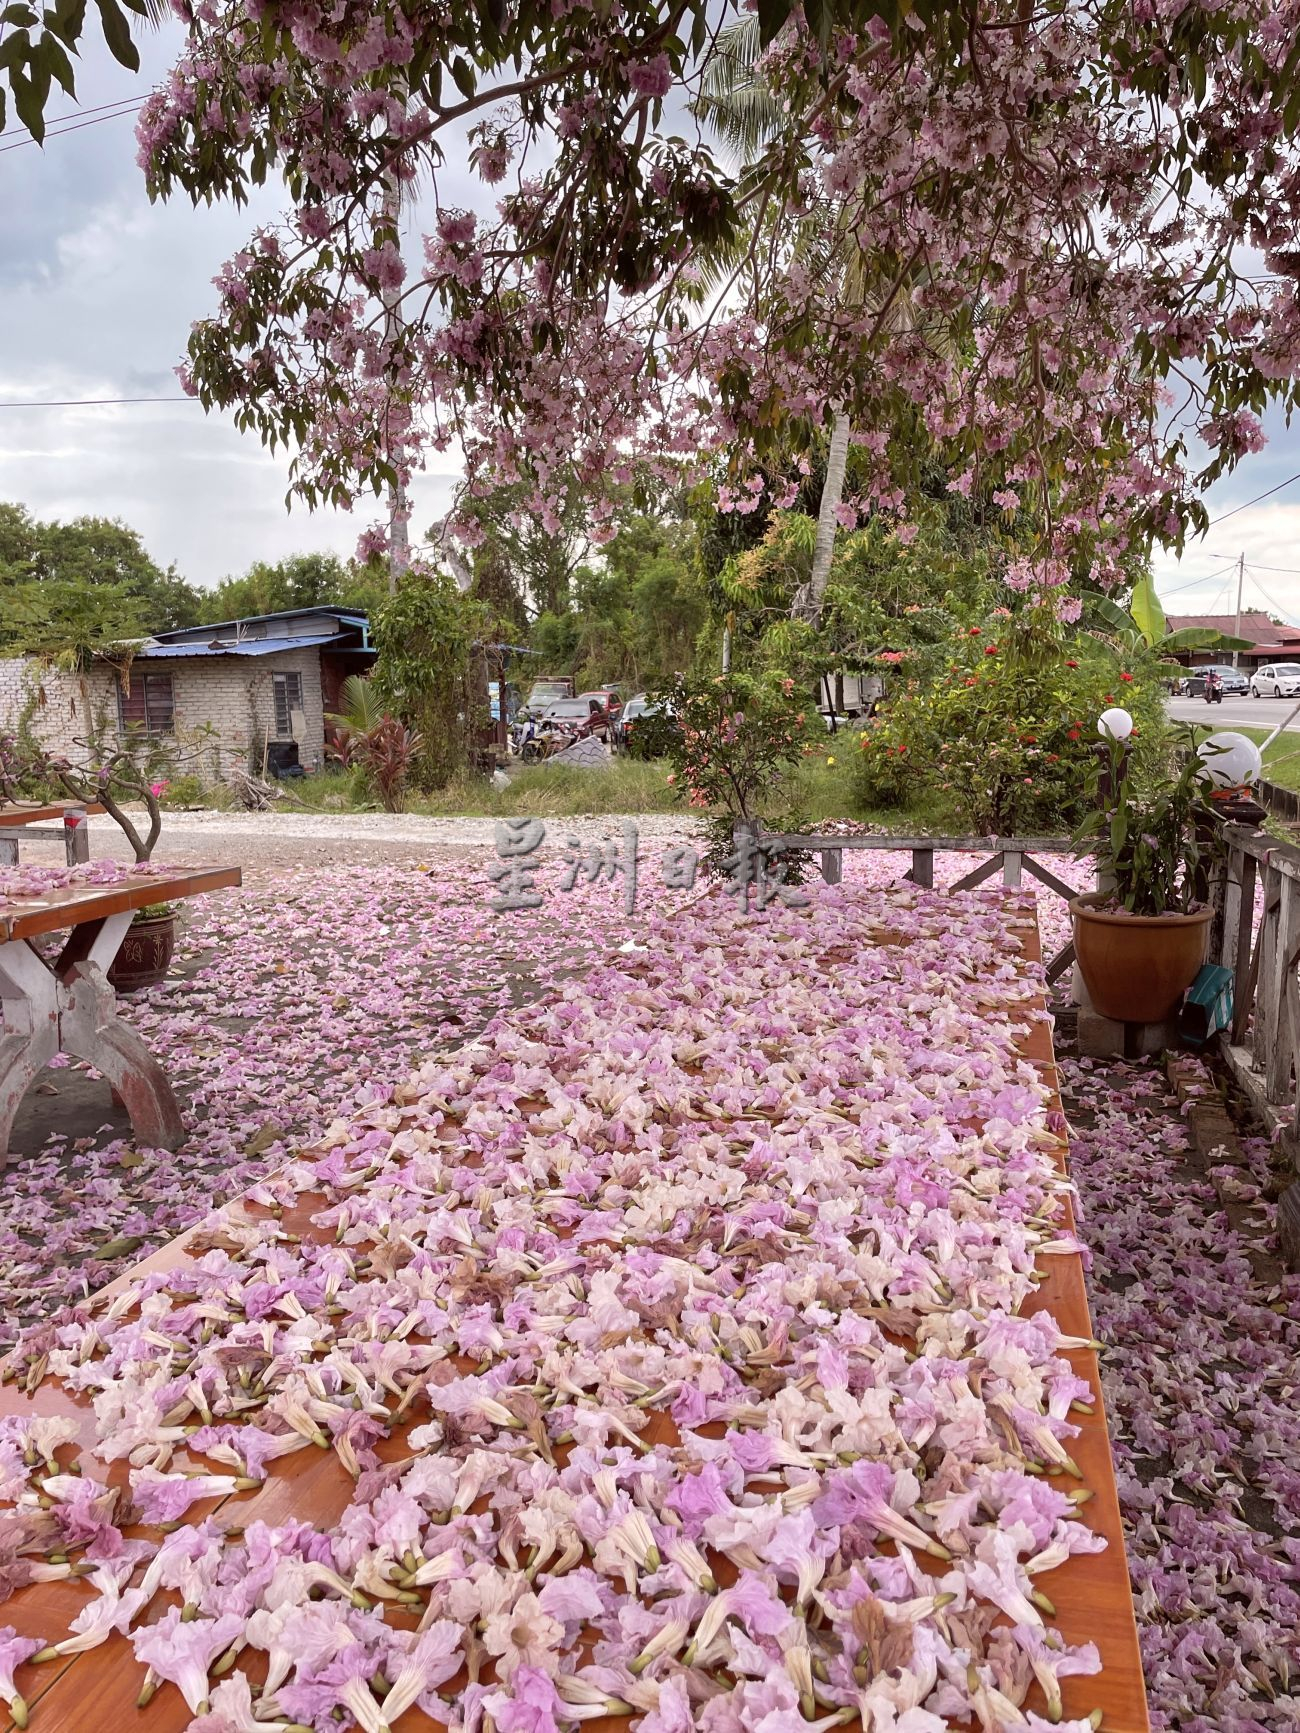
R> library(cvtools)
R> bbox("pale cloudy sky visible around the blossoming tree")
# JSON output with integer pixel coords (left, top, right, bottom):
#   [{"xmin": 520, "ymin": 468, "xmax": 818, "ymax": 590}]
[{"xmin": 0, "ymin": 26, "xmax": 1300, "ymax": 620}]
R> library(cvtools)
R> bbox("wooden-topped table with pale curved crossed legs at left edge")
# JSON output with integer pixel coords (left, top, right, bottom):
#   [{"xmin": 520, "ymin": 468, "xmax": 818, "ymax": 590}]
[{"xmin": 0, "ymin": 867, "xmax": 239, "ymax": 1168}]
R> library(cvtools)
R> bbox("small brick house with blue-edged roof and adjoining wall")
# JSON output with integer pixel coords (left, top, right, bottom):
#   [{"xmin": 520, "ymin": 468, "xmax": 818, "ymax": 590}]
[{"xmin": 0, "ymin": 608, "xmax": 374, "ymax": 780}]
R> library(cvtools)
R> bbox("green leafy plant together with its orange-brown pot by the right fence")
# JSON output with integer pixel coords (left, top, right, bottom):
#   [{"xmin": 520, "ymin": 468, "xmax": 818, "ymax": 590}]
[{"xmin": 1069, "ymin": 724, "xmax": 1219, "ymax": 1022}]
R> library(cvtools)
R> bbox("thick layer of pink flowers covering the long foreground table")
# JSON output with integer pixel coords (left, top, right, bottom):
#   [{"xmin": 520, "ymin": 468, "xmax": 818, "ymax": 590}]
[{"xmin": 0, "ymin": 891, "xmax": 1123, "ymax": 1733}]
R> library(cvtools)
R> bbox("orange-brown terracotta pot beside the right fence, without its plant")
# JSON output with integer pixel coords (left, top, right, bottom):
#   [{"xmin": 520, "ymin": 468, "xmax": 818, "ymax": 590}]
[{"xmin": 1069, "ymin": 891, "xmax": 1213, "ymax": 1022}]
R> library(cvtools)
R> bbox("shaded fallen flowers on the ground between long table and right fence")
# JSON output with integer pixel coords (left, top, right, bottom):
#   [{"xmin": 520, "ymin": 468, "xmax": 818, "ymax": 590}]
[{"xmin": 1063, "ymin": 1061, "xmax": 1300, "ymax": 1733}]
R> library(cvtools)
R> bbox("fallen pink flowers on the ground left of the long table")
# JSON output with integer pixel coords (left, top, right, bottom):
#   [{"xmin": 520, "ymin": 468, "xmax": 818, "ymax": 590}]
[{"xmin": 0, "ymin": 856, "xmax": 648, "ymax": 1347}]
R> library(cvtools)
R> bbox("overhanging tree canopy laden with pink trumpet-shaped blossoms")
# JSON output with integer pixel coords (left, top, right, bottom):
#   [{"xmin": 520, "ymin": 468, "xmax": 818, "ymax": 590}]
[{"xmin": 139, "ymin": 0, "xmax": 1300, "ymax": 594}]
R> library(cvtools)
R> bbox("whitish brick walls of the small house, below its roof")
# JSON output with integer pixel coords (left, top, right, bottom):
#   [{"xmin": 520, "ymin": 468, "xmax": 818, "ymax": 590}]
[{"xmin": 0, "ymin": 648, "xmax": 324, "ymax": 780}]
